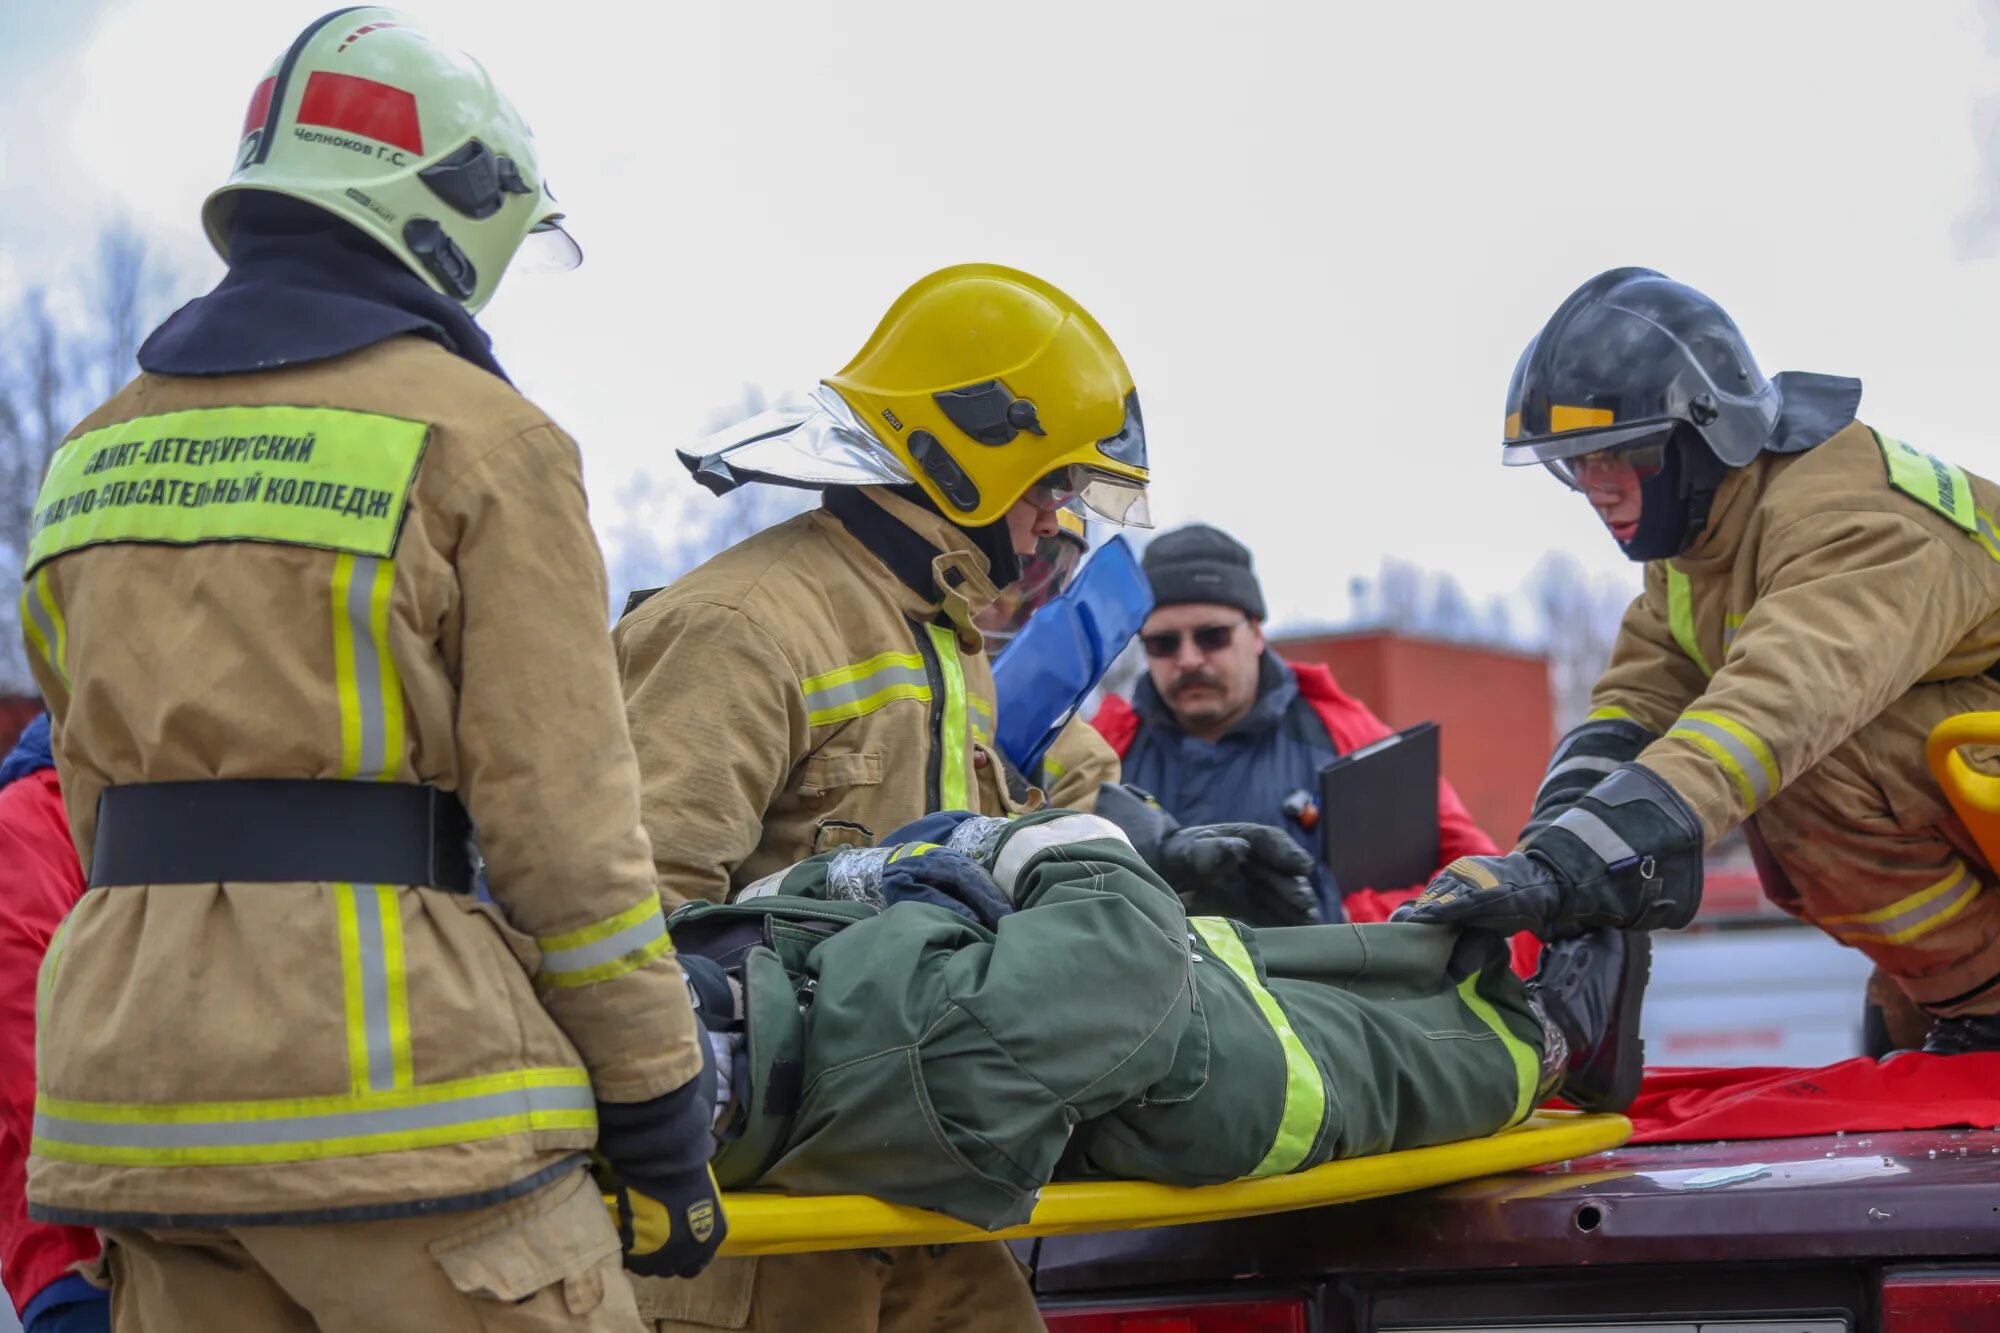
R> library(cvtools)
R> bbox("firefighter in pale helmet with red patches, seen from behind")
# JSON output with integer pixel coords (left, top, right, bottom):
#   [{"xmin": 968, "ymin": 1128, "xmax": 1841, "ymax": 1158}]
[{"xmin": 22, "ymin": 8, "xmax": 724, "ymax": 1333}]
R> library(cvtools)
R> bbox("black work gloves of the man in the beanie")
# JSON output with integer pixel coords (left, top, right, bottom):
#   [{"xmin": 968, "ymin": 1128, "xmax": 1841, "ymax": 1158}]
[{"xmin": 1096, "ymin": 783, "xmax": 1320, "ymax": 925}]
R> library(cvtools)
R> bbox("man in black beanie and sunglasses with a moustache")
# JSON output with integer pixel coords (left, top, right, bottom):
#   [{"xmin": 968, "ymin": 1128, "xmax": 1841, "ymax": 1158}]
[{"xmin": 1092, "ymin": 524, "xmax": 1492, "ymax": 925}]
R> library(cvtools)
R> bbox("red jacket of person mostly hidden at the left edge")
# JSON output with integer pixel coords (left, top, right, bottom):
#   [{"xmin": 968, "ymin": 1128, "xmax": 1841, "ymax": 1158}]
[{"xmin": 0, "ymin": 769, "xmax": 98, "ymax": 1311}]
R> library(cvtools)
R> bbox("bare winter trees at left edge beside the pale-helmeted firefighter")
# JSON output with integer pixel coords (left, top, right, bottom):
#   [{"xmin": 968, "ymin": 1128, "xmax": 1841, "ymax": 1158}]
[{"xmin": 0, "ymin": 224, "xmax": 176, "ymax": 695}]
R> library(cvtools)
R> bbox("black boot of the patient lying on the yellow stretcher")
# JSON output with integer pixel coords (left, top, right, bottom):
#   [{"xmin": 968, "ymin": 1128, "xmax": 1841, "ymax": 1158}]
[{"xmin": 1528, "ymin": 927, "xmax": 1652, "ymax": 1111}]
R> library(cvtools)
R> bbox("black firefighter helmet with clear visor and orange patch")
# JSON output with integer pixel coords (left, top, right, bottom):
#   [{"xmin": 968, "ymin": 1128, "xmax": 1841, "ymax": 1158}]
[{"xmin": 1502, "ymin": 268, "xmax": 1860, "ymax": 560}]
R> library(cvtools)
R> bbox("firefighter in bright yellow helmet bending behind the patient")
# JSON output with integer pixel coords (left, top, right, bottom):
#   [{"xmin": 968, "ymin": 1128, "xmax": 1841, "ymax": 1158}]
[{"xmin": 614, "ymin": 264, "xmax": 1148, "ymax": 1333}]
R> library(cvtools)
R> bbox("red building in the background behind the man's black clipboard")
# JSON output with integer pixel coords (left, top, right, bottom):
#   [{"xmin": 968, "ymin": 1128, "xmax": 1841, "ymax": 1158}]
[{"xmin": 1272, "ymin": 632, "xmax": 1554, "ymax": 849}]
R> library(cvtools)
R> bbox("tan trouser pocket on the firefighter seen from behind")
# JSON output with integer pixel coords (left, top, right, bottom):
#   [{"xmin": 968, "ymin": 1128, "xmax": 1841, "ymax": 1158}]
[{"xmin": 430, "ymin": 1171, "xmax": 632, "ymax": 1329}]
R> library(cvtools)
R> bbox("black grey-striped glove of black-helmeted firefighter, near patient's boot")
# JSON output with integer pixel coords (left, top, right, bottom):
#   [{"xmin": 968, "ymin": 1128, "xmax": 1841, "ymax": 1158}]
[{"xmin": 1390, "ymin": 763, "xmax": 1702, "ymax": 939}]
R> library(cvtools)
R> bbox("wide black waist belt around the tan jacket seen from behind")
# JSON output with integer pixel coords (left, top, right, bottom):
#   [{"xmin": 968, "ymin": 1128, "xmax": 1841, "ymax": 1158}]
[{"xmin": 90, "ymin": 779, "xmax": 472, "ymax": 893}]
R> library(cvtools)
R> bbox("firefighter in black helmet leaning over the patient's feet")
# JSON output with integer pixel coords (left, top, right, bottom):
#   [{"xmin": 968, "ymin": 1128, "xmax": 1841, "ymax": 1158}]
[{"xmin": 1412, "ymin": 268, "xmax": 2000, "ymax": 1053}]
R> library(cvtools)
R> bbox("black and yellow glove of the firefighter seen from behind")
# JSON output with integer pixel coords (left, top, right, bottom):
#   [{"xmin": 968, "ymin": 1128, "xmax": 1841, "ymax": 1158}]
[{"xmin": 592, "ymin": 1041, "xmax": 730, "ymax": 1277}]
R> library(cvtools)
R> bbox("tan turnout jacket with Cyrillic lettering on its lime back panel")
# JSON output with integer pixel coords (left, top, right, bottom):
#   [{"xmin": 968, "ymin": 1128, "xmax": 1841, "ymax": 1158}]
[{"xmin": 24, "ymin": 338, "xmax": 700, "ymax": 1225}]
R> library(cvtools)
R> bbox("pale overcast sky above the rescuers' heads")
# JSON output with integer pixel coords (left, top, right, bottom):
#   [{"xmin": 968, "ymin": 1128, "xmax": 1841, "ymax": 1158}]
[{"xmin": 11, "ymin": 0, "xmax": 2000, "ymax": 620}]
